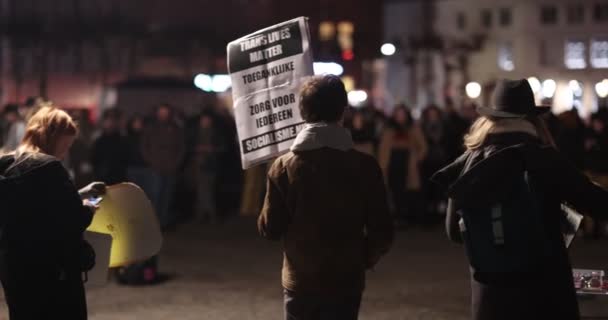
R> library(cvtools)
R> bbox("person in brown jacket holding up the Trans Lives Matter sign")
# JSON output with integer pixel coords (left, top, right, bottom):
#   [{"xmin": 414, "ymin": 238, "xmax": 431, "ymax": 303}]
[{"xmin": 258, "ymin": 75, "xmax": 394, "ymax": 320}]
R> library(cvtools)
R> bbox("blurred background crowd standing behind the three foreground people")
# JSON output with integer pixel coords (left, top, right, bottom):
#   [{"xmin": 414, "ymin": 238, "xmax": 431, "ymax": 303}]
[{"xmin": 0, "ymin": 94, "xmax": 608, "ymax": 231}]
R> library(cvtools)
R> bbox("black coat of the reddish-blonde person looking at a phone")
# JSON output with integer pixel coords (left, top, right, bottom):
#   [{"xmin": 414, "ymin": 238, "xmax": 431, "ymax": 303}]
[{"xmin": 0, "ymin": 154, "xmax": 94, "ymax": 320}]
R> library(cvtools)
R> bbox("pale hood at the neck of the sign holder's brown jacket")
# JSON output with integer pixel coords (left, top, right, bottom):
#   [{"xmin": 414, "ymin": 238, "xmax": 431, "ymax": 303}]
[{"xmin": 291, "ymin": 123, "xmax": 354, "ymax": 152}]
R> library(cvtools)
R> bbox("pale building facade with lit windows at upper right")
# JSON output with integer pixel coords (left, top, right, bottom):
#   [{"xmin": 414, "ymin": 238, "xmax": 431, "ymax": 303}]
[{"xmin": 385, "ymin": 0, "xmax": 608, "ymax": 116}]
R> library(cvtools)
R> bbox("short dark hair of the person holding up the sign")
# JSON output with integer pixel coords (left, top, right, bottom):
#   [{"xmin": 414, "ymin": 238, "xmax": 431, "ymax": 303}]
[{"xmin": 300, "ymin": 75, "xmax": 348, "ymax": 122}]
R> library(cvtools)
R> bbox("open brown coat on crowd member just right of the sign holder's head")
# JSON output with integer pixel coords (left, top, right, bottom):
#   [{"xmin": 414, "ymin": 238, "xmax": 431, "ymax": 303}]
[{"xmin": 378, "ymin": 126, "xmax": 427, "ymax": 191}]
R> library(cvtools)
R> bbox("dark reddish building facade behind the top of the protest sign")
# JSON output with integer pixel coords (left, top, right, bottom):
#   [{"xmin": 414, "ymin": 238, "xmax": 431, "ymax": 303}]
[{"xmin": 0, "ymin": 0, "xmax": 382, "ymax": 112}]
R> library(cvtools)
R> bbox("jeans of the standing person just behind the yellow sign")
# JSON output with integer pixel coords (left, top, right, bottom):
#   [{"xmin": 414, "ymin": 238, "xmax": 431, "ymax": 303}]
[{"xmin": 127, "ymin": 167, "xmax": 175, "ymax": 228}]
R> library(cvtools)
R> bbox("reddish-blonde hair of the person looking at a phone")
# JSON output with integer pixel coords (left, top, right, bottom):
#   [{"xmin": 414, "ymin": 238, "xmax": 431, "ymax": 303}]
[{"xmin": 17, "ymin": 106, "xmax": 78, "ymax": 154}]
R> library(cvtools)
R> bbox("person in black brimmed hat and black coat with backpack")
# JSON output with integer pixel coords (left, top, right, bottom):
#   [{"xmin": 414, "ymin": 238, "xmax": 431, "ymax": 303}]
[{"xmin": 432, "ymin": 80, "xmax": 608, "ymax": 320}]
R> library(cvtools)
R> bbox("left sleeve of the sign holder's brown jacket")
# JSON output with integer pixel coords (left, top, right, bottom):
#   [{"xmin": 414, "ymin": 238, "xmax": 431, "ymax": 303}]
[{"xmin": 258, "ymin": 160, "xmax": 289, "ymax": 241}]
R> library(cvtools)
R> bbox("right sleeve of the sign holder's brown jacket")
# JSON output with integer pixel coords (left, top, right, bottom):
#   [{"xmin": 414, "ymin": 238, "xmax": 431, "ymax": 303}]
[{"xmin": 365, "ymin": 161, "xmax": 395, "ymax": 268}]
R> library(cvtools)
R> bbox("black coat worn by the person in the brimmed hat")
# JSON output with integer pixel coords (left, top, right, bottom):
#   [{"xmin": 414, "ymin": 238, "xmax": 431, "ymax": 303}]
[{"xmin": 433, "ymin": 133, "xmax": 608, "ymax": 320}]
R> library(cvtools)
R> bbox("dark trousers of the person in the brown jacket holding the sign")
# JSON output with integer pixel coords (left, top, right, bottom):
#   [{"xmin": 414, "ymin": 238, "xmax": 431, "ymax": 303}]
[{"xmin": 284, "ymin": 290, "xmax": 362, "ymax": 320}]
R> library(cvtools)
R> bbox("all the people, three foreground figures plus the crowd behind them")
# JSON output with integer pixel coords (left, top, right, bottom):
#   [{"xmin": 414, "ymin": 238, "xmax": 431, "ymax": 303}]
[{"xmin": 0, "ymin": 75, "xmax": 608, "ymax": 320}]
